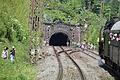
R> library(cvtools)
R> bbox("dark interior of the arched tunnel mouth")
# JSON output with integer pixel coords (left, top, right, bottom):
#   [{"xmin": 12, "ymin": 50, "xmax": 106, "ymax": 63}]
[{"xmin": 49, "ymin": 32, "xmax": 70, "ymax": 46}]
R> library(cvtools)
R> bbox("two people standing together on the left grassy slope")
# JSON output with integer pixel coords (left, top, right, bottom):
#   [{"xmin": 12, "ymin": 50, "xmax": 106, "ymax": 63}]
[{"xmin": 1, "ymin": 46, "xmax": 15, "ymax": 63}]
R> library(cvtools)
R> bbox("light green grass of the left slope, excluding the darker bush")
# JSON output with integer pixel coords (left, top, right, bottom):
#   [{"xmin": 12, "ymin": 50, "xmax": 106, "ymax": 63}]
[{"xmin": 0, "ymin": 0, "xmax": 35, "ymax": 80}]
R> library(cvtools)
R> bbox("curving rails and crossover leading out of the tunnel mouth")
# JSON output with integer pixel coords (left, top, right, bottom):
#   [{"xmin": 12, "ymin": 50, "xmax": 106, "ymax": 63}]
[{"xmin": 53, "ymin": 46, "xmax": 86, "ymax": 80}]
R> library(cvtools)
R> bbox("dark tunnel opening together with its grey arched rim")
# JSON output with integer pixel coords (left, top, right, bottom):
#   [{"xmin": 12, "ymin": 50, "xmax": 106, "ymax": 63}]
[{"xmin": 49, "ymin": 30, "xmax": 72, "ymax": 46}]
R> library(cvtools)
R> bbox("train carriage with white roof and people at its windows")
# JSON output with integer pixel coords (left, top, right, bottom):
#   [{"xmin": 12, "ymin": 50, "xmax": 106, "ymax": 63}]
[{"xmin": 109, "ymin": 21, "xmax": 120, "ymax": 66}]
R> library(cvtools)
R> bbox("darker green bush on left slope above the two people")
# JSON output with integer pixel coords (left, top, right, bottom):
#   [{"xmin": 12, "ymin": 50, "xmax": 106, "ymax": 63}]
[{"xmin": 0, "ymin": 12, "xmax": 24, "ymax": 42}]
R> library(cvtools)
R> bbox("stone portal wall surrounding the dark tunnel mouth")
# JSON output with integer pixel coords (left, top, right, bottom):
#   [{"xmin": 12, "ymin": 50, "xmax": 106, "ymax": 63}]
[{"xmin": 43, "ymin": 23, "xmax": 80, "ymax": 46}]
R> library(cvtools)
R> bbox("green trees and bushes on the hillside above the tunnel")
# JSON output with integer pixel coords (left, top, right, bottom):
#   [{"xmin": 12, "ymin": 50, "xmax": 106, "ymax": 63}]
[{"xmin": 44, "ymin": 0, "xmax": 120, "ymax": 45}]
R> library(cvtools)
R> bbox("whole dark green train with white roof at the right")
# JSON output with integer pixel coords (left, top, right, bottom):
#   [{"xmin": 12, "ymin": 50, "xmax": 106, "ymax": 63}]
[{"xmin": 99, "ymin": 18, "xmax": 120, "ymax": 71}]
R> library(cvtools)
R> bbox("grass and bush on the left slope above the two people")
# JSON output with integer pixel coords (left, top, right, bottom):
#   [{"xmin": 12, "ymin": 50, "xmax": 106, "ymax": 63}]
[{"xmin": 0, "ymin": 0, "xmax": 29, "ymax": 42}]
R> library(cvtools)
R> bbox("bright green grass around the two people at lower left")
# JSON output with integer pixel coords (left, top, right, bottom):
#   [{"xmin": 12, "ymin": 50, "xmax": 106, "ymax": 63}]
[{"xmin": 0, "ymin": 42, "xmax": 36, "ymax": 80}]
